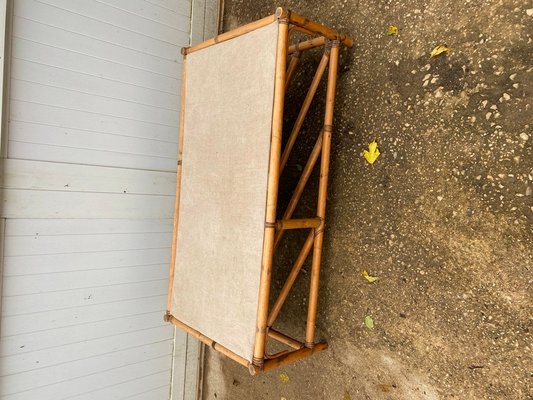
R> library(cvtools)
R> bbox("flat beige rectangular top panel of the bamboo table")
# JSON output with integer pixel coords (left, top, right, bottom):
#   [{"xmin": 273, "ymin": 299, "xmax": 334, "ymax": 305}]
[{"xmin": 170, "ymin": 22, "xmax": 278, "ymax": 361}]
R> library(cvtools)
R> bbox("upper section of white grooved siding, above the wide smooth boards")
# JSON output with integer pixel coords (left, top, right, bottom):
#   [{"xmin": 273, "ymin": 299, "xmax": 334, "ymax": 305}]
[{"xmin": 8, "ymin": 0, "xmax": 191, "ymax": 171}]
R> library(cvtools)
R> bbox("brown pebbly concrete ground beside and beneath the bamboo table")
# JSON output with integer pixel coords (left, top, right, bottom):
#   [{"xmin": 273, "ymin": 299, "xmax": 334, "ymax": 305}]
[{"xmin": 204, "ymin": 0, "xmax": 533, "ymax": 400}]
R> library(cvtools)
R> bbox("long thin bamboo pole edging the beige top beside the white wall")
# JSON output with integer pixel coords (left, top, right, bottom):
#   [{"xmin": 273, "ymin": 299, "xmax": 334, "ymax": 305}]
[{"xmin": 167, "ymin": 54, "xmax": 187, "ymax": 313}]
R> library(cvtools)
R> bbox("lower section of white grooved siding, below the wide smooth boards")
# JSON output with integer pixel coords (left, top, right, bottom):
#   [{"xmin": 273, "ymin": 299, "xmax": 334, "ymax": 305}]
[{"xmin": 0, "ymin": 219, "xmax": 173, "ymax": 399}]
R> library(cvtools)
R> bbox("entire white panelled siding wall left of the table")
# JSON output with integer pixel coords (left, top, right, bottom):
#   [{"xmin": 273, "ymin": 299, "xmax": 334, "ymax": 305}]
[{"xmin": 0, "ymin": 0, "xmax": 195, "ymax": 400}]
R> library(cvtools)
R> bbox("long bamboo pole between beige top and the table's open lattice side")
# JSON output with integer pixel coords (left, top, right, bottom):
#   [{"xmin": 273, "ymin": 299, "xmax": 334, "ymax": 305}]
[{"xmin": 253, "ymin": 18, "xmax": 289, "ymax": 367}]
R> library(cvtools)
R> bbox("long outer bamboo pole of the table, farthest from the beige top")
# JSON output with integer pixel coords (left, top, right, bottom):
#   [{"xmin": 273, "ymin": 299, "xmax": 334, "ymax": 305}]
[{"xmin": 305, "ymin": 41, "xmax": 339, "ymax": 347}]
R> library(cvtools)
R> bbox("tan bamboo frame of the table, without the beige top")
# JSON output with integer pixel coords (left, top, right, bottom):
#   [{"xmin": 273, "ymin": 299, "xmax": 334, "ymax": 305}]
[{"xmin": 165, "ymin": 8, "xmax": 353, "ymax": 375}]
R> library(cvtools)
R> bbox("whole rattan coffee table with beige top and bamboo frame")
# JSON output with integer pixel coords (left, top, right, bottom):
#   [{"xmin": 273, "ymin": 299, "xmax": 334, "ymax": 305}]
[{"xmin": 165, "ymin": 8, "xmax": 352, "ymax": 374}]
